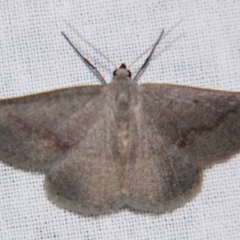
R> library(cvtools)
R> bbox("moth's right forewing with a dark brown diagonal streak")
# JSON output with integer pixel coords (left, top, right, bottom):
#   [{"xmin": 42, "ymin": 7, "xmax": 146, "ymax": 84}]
[{"xmin": 140, "ymin": 84, "xmax": 240, "ymax": 165}]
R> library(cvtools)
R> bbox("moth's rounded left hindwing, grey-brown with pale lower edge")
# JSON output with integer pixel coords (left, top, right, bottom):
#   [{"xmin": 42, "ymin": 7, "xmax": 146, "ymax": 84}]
[{"xmin": 45, "ymin": 102, "xmax": 122, "ymax": 214}]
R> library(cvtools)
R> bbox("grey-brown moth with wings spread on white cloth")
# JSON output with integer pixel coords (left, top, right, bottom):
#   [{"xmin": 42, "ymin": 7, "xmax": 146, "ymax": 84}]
[{"xmin": 0, "ymin": 28, "xmax": 240, "ymax": 214}]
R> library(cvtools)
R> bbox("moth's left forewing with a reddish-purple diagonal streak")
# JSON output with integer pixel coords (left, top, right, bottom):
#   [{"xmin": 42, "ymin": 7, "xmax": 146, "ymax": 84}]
[{"xmin": 0, "ymin": 85, "xmax": 104, "ymax": 169}]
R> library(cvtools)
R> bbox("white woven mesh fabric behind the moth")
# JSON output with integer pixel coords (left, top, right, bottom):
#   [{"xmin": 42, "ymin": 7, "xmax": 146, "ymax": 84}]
[{"xmin": 0, "ymin": 0, "xmax": 240, "ymax": 239}]
